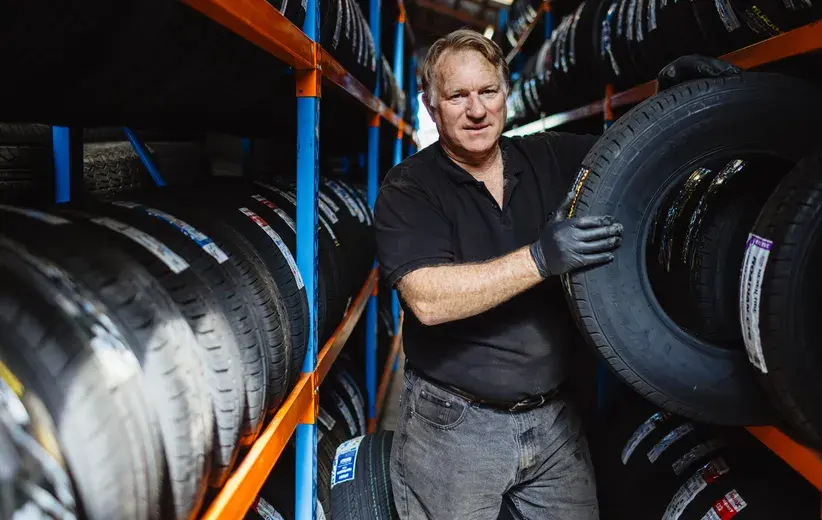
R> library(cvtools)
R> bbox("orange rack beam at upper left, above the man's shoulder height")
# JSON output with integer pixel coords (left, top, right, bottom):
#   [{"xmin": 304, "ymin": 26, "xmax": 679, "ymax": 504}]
[{"xmin": 183, "ymin": 0, "xmax": 412, "ymax": 135}]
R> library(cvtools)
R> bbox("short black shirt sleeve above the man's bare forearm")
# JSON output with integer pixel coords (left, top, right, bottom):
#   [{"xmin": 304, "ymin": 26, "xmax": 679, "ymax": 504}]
[{"xmin": 374, "ymin": 174, "xmax": 454, "ymax": 287}]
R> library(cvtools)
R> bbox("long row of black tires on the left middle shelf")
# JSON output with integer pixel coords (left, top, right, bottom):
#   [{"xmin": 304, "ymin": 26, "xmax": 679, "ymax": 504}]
[{"xmin": 0, "ymin": 172, "xmax": 374, "ymax": 520}]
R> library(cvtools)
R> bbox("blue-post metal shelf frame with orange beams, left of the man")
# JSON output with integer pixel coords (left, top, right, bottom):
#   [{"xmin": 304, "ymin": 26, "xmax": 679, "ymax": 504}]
[{"xmin": 46, "ymin": 0, "xmax": 417, "ymax": 520}]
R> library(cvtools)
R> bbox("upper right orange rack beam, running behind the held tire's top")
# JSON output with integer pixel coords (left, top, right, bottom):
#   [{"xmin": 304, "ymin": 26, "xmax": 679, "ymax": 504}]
[{"xmin": 505, "ymin": 21, "xmax": 822, "ymax": 136}]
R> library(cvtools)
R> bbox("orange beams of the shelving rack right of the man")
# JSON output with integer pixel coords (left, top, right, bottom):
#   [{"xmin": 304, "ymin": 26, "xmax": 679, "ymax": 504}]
[{"xmin": 504, "ymin": 17, "xmax": 822, "ymax": 491}]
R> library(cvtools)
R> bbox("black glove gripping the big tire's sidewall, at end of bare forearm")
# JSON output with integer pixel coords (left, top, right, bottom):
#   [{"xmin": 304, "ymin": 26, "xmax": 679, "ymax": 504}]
[{"xmin": 531, "ymin": 191, "xmax": 622, "ymax": 278}]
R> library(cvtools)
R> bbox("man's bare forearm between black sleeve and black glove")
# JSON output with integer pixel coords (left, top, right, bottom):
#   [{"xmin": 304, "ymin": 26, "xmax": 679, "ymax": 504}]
[{"xmin": 398, "ymin": 247, "xmax": 542, "ymax": 325}]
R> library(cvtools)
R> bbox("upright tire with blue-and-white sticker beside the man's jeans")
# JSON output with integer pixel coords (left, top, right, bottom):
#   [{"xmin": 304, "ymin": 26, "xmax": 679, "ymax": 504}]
[{"xmin": 331, "ymin": 431, "xmax": 399, "ymax": 520}]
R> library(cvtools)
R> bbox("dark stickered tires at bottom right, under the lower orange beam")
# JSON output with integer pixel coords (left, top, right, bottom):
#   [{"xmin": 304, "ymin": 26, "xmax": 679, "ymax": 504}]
[{"xmin": 592, "ymin": 394, "xmax": 819, "ymax": 520}]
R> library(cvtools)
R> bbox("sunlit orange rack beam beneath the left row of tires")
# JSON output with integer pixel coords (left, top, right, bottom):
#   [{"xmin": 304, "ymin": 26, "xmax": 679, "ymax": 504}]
[{"xmin": 201, "ymin": 270, "xmax": 377, "ymax": 520}]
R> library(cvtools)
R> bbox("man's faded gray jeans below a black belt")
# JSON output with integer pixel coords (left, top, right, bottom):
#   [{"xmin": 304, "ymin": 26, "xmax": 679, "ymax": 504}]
[{"xmin": 391, "ymin": 369, "xmax": 599, "ymax": 520}]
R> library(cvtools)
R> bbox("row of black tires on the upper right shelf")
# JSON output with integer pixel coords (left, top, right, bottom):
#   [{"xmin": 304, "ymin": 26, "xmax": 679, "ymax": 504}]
[{"xmin": 507, "ymin": 0, "xmax": 822, "ymax": 127}]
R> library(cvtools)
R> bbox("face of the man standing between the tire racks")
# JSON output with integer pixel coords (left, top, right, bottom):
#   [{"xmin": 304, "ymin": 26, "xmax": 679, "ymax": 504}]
[{"xmin": 431, "ymin": 50, "xmax": 505, "ymax": 156}]
